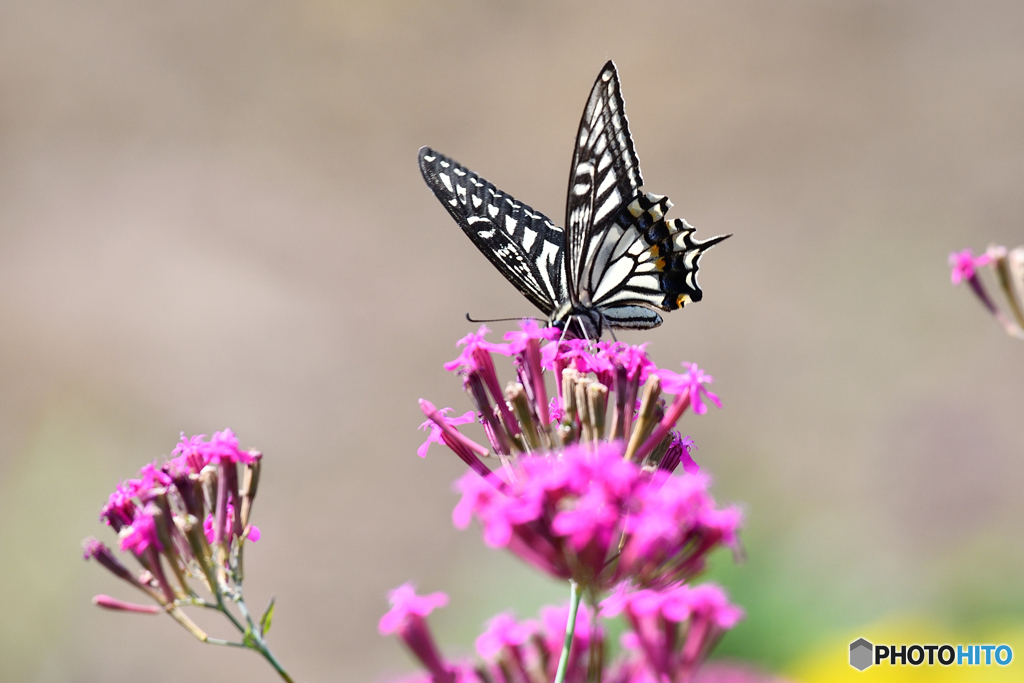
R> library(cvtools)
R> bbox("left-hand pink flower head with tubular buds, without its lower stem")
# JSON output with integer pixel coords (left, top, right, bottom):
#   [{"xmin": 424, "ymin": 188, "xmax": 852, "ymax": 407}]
[{"xmin": 83, "ymin": 436, "xmax": 262, "ymax": 611}]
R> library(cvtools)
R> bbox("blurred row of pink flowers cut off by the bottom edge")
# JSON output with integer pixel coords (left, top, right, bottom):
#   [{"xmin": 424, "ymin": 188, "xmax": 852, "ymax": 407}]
[{"xmin": 379, "ymin": 584, "xmax": 770, "ymax": 683}]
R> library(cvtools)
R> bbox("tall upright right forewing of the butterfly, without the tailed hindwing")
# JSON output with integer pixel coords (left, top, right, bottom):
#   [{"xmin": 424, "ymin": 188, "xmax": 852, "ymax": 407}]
[{"xmin": 565, "ymin": 61, "xmax": 643, "ymax": 303}]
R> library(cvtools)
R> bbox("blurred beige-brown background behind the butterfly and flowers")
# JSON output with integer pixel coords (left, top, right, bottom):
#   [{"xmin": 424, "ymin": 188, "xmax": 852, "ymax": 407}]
[{"xmin": 0, "ymin": 0, "xmax": 1024, "ymax": 683}]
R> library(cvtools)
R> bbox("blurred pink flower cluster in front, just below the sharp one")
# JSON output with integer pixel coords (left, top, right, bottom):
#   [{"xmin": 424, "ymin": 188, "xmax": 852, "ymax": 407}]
[{"xmin": 453, "ymin": 442, "xmax": 741, "ymax": 590}]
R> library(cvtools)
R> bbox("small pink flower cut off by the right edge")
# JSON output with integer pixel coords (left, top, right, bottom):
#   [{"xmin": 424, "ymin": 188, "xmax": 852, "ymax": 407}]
[{"xmin": 949, "ymin": 245, "xmax": 1024, "ymax": 339}]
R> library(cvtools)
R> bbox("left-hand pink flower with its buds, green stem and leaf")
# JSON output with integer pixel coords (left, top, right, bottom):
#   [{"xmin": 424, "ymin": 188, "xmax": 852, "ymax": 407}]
[{"xmin": 83, "ymin": 429, "xmax": 291, "ymax": 681}]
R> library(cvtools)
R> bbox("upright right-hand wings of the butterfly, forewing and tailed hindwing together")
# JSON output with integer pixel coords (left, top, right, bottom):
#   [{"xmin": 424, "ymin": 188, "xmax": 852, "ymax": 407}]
[{"xmin": 565, "ymin": 60, "xmax": 728, "ymax": 329}]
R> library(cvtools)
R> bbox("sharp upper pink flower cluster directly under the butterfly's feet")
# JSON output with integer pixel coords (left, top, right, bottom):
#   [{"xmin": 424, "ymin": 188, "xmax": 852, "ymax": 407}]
[{"xmin": 418, "ymin": 321, "xmax": 721, "ymax": 476}]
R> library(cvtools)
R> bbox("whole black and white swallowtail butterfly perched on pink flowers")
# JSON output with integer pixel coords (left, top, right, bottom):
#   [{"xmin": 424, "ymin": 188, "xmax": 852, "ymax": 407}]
[{"xmin": 420, "ymin": 60, "xmax": 729, "ymax": 339}]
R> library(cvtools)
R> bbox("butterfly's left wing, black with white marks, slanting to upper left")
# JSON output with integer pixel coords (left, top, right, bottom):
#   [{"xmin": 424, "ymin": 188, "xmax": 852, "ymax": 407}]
[{"xmin": 420, "ymin": 147, "xmax": 568, "ymax": 316}]
